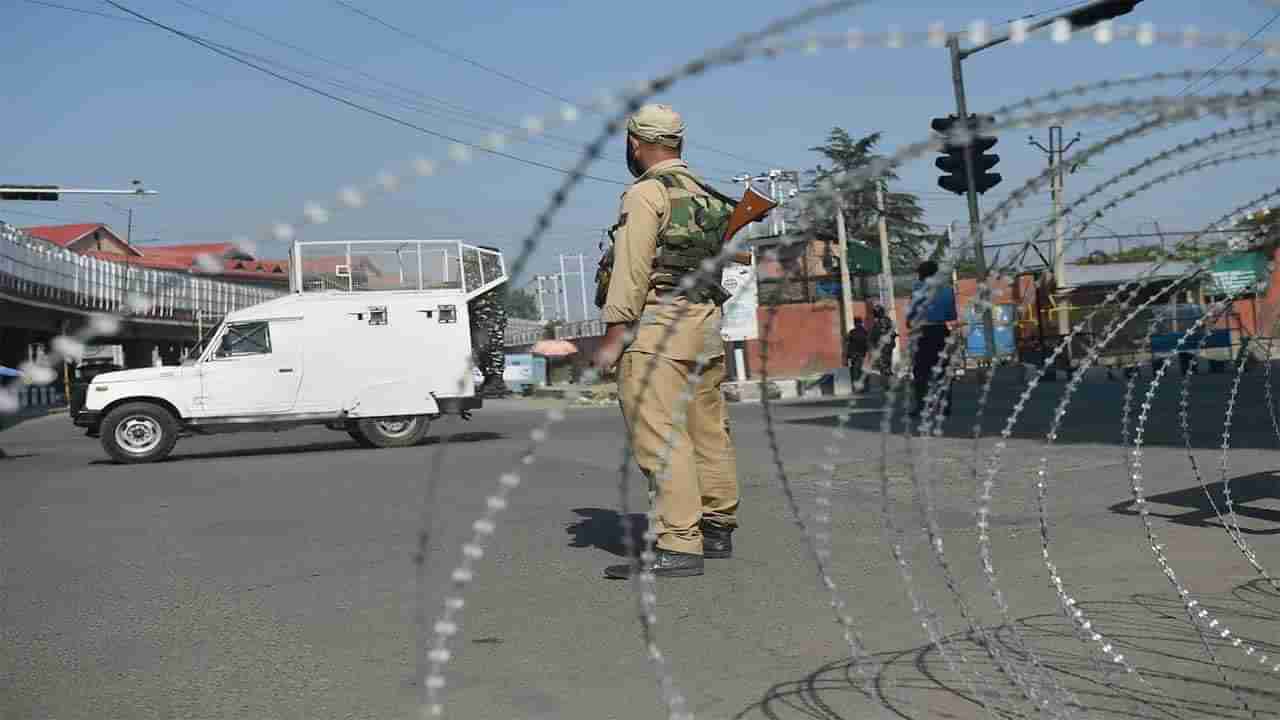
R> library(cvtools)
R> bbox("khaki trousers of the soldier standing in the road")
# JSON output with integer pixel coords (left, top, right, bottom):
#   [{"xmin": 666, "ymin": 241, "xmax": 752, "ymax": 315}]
[{"xmin": 618, "ymin": 352, "xmax": 739, "ymax": 555}]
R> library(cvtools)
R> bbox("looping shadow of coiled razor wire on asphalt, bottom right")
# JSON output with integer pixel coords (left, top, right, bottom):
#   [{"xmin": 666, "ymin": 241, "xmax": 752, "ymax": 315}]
[{"xmin": 733, "ymin": 580, "xmax": 1280, "ymax": 720}]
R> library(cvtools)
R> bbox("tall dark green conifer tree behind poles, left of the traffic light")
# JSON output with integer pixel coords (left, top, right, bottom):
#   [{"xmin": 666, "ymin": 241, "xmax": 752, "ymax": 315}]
[{"xmin": 797, "ymin": 127, "xmax": 946, "ymax": 272}]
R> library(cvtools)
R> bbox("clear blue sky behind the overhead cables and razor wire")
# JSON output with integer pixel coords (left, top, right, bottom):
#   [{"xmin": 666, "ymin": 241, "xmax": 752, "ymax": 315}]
[{"xmin": 0, "ymin": 0, "xmax": 1280, "ymax": 297}]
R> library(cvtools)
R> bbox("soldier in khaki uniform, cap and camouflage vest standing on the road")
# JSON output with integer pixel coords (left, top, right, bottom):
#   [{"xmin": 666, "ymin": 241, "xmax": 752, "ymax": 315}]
[{"xmin": 594, "ymin": 105, "xmax": 750, "ymax": 578}]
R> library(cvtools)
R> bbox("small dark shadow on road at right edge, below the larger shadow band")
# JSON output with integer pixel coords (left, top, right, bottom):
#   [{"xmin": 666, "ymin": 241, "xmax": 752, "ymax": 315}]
[{"xmin": 1110, "ymin": 471, "xmax": 1280, "ymax": 536}]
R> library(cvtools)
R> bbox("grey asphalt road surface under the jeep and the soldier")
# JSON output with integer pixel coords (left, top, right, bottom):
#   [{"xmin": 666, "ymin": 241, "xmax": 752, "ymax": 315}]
[{"xmin": 0, "ymin": 375, "xmax": 1280, "ymax": 720}]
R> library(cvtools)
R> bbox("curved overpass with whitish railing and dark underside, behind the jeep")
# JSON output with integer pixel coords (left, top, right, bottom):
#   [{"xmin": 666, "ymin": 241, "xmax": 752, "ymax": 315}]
[{"xmin": 0, "ymin": 222, "xmax": 284, "ymax": 368}]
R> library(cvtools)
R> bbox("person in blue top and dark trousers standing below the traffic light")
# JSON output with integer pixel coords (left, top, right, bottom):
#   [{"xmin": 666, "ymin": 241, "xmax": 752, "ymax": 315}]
[{"xmin": 906, "ymin": 260, "xmax": 956, "ymax": 418}]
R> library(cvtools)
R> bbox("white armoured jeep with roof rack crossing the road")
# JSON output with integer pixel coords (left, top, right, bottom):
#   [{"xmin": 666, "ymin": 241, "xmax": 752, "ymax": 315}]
[{"xmin": 73, "ymin": 245, "xmax": 506, "ymax": 462}]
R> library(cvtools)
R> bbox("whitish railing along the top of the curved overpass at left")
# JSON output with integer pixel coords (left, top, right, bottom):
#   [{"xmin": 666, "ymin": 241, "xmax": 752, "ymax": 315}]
[{"xmin": 0, "ymin": 223, "xmax": 284, "ymax": 323}]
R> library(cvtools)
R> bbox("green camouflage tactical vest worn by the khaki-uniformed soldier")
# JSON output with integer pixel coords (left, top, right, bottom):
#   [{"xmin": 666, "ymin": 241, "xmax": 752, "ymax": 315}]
[{"xmin": 595, "ymin": 168, "xmax": 736, "ymax": 307}]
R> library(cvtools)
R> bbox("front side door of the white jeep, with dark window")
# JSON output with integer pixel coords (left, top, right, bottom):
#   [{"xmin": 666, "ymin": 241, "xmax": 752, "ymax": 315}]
[{"xmin": 193, "ymin": 319, "xmax": 302, "ymax": 418}]
